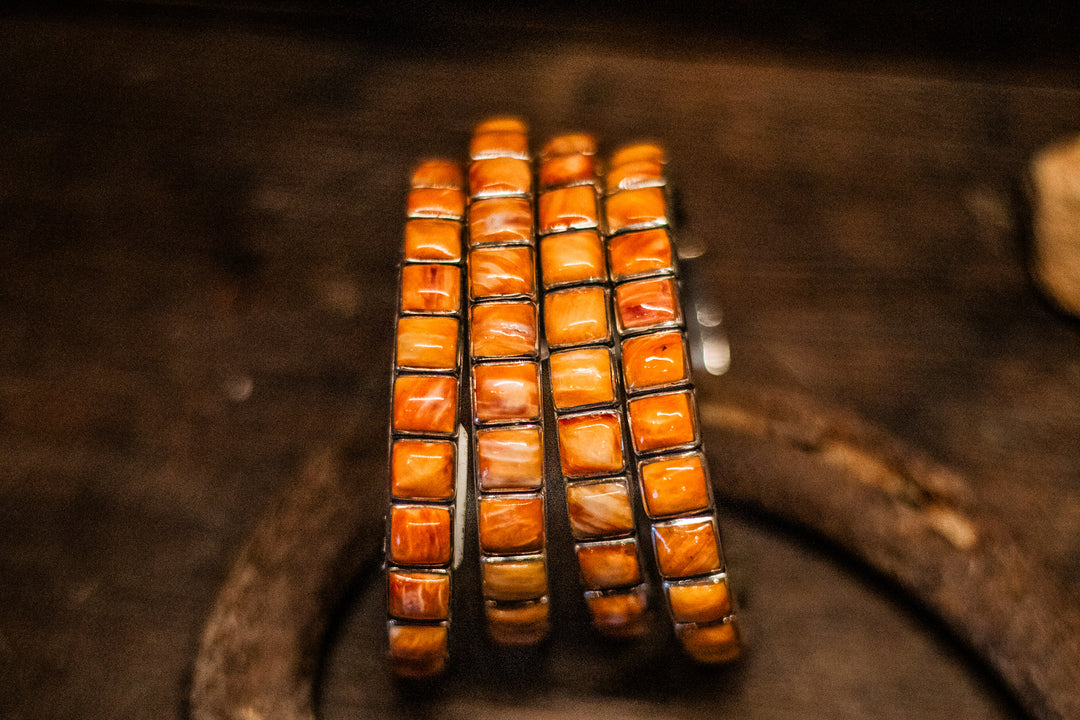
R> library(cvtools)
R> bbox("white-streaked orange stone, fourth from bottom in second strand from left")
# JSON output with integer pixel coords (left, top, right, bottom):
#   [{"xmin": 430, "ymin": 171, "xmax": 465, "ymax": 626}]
[{"xmin": 476, "ymin": 425, "xmax": 543, "ymax": 492}]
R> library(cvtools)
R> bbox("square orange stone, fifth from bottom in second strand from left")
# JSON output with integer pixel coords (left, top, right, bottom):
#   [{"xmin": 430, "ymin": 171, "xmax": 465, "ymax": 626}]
[{"xmin": 473, "ymin": 363, "xmax": 540, "ymax": 422}]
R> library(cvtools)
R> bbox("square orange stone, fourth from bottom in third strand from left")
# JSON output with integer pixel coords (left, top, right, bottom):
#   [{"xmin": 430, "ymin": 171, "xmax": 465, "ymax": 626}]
[{"xmin": 557, "ymin": 410, "xmax": 624, "ymax": 477}]
